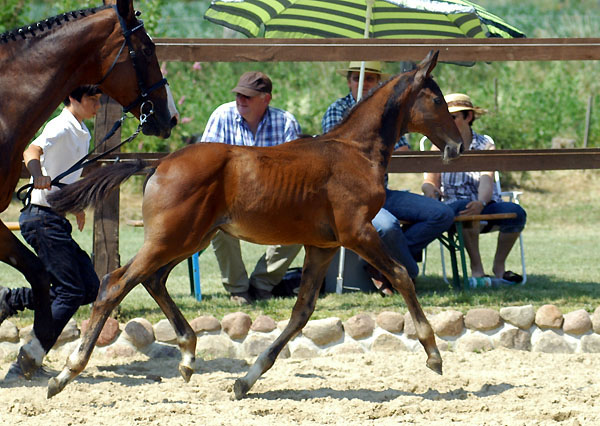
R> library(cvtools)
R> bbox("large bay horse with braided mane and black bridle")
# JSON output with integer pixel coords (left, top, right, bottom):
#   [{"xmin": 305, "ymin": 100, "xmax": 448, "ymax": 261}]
[{"xmin": 0, "ymin": 0, "xmax": 175, "ymax": 377}]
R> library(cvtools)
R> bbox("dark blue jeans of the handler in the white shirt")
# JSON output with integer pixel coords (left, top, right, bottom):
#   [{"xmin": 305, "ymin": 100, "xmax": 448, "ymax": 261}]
[{"xmin": 8, "ymin": 205, "xmax": 100, "ymax": 348}]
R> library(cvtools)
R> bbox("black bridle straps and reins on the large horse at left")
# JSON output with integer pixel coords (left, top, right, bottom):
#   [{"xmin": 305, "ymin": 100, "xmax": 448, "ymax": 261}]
[{"xmin": 17, "ymin": 5, "xmax": 168, "ymax": 211}]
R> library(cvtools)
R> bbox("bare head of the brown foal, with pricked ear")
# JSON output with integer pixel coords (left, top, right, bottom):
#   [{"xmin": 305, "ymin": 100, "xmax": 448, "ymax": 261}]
[{"xmin": 407, "ymin": 51, "xmax": 464, "ymax": 162}]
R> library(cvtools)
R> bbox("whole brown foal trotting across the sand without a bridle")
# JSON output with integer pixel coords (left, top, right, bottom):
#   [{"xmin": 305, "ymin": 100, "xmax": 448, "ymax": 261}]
[{"xmin": 48, "ymin": 52, "xmax": 462, "ymax": 398}]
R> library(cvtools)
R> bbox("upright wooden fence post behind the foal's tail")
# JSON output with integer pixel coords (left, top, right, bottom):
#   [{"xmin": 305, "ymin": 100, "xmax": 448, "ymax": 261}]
[{"xmin": 92, "ymin": 95, "xmax": 122, "ymax": 278}]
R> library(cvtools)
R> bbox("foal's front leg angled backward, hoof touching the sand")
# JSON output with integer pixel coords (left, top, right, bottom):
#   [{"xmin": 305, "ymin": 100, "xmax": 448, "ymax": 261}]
[{"xmin": 233, "ymin": 246, "xmax": 337, "ymax": 399}]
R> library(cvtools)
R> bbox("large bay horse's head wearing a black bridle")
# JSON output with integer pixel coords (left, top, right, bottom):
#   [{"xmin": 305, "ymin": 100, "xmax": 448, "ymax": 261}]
[{"xmin": 100, "ymin": 0, "xmax": 177, "ymax": 138}]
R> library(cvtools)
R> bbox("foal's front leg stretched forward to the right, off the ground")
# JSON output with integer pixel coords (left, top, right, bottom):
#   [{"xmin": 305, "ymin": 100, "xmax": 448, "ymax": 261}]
[{"xmin": 351, "ymin": 228, "xmax": 442, "ymax": 374}]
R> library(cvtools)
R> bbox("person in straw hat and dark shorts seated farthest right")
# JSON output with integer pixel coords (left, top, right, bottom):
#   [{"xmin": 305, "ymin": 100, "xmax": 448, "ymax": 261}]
[{"xmin": 422, "ymin": 93, "xmax": 527, "ymax": 287}]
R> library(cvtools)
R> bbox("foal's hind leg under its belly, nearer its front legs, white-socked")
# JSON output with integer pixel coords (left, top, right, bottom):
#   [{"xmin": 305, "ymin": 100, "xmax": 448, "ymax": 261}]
[{"xmin": 143, "ymin": 261, "xmax": 196, "ymax": 382}]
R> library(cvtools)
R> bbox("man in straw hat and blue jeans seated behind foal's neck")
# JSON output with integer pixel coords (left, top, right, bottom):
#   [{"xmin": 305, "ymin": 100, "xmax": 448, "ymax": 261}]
[{"xmin": 321, "ymin": 61, "xmax": 454, "ymax": 296}]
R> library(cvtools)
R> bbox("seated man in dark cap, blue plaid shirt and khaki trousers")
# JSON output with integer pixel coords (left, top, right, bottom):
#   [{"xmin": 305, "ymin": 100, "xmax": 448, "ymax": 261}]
[{"xmin": 202, "ymin": 71, "xmax": 302, "ymax": 304}]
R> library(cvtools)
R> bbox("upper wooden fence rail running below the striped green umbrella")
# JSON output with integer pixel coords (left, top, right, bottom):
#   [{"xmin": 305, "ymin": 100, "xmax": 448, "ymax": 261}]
[{"xmin": 155, "ymin": 38, "xmax": 600, "ymax": 62}]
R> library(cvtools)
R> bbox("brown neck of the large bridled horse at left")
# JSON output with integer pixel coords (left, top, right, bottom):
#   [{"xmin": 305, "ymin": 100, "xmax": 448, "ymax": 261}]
[{"xmin": 0, "ymin": 11, "xmax": 118, "ymax": 166}]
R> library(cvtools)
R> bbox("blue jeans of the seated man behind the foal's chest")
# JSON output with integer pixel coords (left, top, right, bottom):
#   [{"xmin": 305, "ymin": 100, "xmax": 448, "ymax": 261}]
[{"xmin": 372, "ymin": 189, "xmax": 454, "ymax": 278}]
